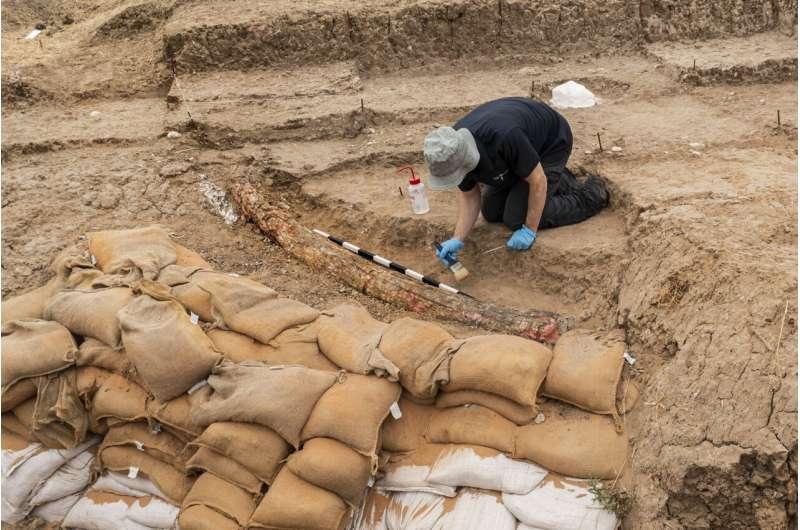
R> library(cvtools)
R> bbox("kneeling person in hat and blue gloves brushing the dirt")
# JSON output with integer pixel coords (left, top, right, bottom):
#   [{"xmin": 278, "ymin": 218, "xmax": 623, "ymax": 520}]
[{"xmin": 424, "ymin": 98, "xmax": 608, "ymax": 263}]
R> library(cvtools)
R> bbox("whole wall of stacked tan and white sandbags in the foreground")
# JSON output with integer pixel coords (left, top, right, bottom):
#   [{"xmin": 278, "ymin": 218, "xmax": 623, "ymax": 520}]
[{"xmin": 2, "ymin": 227, "xmax": 631, "ymax": 530}]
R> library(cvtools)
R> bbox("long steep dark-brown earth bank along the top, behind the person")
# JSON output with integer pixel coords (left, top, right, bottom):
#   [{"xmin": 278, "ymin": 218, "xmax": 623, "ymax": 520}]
[{"xmin": 165, "ymin": 0, "xmax": 640, "ymax": 72}]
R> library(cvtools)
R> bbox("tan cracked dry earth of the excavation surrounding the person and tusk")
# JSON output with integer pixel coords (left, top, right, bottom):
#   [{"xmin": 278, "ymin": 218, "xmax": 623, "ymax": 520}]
[{"xmin": 2, "ymin": 0, "xmax": 797, "ymax": 529}]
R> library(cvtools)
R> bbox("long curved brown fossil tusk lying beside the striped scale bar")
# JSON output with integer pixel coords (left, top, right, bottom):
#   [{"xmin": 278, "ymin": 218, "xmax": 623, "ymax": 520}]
[{"xmin": 230, "ymin": 183, "xmax": 565, "ymax": 344}]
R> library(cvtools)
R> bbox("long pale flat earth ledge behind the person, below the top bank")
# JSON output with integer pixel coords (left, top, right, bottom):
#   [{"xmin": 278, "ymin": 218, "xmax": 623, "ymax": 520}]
[{"xmin": 168, "ymin": 54, "xmax": 678, "ymax": 142}]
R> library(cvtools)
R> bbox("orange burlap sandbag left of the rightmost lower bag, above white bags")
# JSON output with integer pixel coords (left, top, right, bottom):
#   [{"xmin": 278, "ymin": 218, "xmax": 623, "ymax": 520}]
[{"xmin": 425, "ymin": 405, "xmax": 517, "ymax": 454}]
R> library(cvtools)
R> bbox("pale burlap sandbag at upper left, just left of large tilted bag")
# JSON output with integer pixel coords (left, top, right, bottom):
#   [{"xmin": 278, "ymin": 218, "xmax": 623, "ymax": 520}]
[{"xmin": 44, "ymin": 287, "xmax": 133, "ymax": 347}]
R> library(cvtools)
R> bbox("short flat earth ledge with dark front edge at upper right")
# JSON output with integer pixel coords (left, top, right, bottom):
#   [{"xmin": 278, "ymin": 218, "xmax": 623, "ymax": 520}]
[{"xmin": 647, "ymin": 32, "xmax": 797, "ymax": 85}]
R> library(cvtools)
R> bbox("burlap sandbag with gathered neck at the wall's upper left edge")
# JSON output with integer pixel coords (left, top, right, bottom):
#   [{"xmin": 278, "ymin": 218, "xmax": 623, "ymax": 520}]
[{"xmin": 0, "ymin": 248, "xmax": 100, "ymax": 325}]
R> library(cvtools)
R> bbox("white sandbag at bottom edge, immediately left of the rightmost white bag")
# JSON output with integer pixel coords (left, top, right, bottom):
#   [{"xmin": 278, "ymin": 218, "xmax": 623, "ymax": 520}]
[{"xmin": 432, "ymin": 489, "xmax": 517, "ymax": 530}]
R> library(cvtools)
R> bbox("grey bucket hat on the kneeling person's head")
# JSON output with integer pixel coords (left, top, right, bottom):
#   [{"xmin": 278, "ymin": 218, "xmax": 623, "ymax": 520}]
[{"xmin": 423, "ymin": 127, "xmax": 480, "ymax": 190}]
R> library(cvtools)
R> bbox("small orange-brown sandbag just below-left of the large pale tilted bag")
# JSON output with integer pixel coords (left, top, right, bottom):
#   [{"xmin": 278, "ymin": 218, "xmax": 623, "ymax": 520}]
[{"xmin": 91, "ymin": 374, "xmax": 148, "ymax": 424}]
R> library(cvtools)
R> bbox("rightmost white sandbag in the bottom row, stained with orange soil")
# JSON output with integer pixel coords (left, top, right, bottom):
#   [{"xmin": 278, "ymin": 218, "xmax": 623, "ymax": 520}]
[{"xmin": 503, "ymin": 475, "xmax": 617, "ymax": 530}]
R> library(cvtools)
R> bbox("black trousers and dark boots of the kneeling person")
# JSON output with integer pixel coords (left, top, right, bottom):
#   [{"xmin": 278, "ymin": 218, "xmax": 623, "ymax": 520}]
[{"xmin": 481, "ymin": 145, "xmax": 608, "ymax": 230}]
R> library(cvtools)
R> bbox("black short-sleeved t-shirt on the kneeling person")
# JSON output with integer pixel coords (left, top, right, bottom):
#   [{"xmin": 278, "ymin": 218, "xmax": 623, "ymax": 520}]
[{"xmin": 453, "ymin": 98, "xmax": 572, "ymax": 191}]
